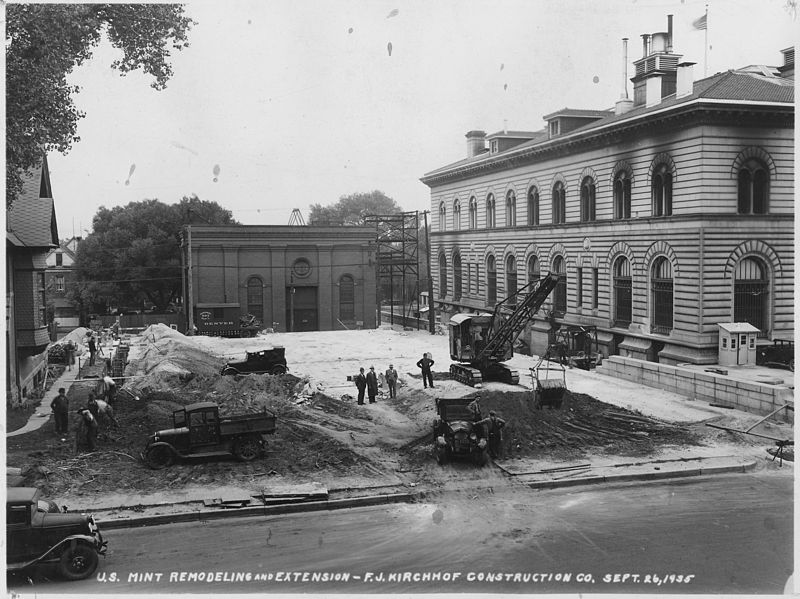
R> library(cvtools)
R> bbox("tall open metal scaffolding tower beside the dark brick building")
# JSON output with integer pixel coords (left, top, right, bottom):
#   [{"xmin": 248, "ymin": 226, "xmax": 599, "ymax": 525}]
[{"xmin": 366, "ymin": 211, "xmax": 420, "ymax": 328}]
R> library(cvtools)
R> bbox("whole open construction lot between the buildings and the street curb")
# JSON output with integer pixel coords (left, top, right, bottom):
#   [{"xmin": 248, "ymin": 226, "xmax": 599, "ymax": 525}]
[{"xmin": 7, "ymin": 304, "xmax": 792, "ymax": 501}]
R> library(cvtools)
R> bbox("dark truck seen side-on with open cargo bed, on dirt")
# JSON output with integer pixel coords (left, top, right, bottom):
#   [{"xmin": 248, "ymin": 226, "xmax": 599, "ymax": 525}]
[{"xmin": 141, "ymin": 401, "xmax": 276, "ymax": 469}]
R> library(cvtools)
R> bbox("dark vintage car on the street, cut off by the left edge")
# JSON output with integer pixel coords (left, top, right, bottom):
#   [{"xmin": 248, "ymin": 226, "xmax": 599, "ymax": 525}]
[{"xmin": 6, "ymin": 487, "xmax": 107, "ymax": 580}]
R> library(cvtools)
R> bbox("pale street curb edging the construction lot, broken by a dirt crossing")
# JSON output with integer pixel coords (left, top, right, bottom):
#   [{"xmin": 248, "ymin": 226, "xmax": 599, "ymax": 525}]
[{"xmin": 97, "ymin": 460, "xmax": 756, "ymax": 530}]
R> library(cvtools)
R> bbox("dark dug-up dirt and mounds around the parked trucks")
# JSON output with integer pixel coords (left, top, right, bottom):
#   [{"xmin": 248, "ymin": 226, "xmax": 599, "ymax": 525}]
[{"xmin": 7, "ymin": 325, "xmax": 724, "ymax": 496}]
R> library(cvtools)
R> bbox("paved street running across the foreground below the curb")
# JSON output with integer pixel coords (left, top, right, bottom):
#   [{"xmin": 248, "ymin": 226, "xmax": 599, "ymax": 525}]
[{"xmin": 9, "ymin": 470, "xmax": 793, "ymax": 596}]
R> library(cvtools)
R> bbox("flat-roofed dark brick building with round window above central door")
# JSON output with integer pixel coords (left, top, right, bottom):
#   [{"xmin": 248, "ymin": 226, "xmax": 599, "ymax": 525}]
[{"xmin": 184, "ymin": 225, "xmax": 376, "ymax": 332}]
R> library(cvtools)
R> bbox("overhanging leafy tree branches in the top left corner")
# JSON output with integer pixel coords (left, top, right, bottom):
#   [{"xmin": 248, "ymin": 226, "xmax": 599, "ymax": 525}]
[{"xmin": 5, "ymin": 3, "xmax": 194, "ymax": 208}]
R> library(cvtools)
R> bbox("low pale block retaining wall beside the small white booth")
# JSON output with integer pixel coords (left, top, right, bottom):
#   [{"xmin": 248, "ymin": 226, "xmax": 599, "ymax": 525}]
[{"xmin": 596, "ymin": 356, "xmax": 794, "ymax": 420}]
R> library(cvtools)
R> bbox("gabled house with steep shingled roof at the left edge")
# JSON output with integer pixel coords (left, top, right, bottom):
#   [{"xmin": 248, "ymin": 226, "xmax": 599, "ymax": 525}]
[{"xmin": 6, "ymin": 156, "xmax": 58, "ymax": 404}]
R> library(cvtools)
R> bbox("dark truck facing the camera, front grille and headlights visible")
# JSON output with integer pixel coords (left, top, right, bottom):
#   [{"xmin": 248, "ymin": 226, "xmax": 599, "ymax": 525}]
[{"xmin": 433, "ymin": 397, "xmax": 489, "ymax": 466}]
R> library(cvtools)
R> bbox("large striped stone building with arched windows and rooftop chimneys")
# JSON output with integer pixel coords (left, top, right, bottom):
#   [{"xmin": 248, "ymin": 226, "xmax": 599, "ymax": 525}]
[{"xmin": 422, "ymin": 19, "xmax": 795, "ymax": 364}]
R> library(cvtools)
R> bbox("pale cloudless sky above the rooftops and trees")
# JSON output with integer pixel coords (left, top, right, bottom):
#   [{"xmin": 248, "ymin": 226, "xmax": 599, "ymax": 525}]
[{"xmin": 43, "ymin": 0, "xmax": 797, "ymax": 239}]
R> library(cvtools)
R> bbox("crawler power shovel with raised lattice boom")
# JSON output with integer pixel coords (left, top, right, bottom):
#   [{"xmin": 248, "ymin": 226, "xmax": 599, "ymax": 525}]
[{"xmin": 449, "ymin": 273, "xmax": 563, "ymax": 387}]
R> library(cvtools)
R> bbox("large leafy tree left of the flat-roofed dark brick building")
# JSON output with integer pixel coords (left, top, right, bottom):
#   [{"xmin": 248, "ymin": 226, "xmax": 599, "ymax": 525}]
[{"xmin": 69, "ymin": 196, "xmax": 237, "ymax": 311}]
